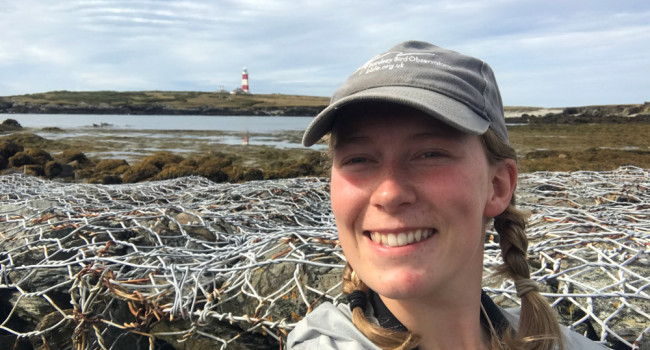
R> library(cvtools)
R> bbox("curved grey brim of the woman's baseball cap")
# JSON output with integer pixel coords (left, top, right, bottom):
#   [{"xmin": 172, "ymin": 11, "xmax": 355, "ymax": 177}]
[{"xmin": 302, "ymin": 86, "xmax": 490, "ymax": 147}]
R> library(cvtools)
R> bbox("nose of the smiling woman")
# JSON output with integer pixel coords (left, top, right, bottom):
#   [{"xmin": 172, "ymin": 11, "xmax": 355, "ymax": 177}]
[{"xmin": 370, "ymin": 165, "xmax": 416, "ymax": 212}]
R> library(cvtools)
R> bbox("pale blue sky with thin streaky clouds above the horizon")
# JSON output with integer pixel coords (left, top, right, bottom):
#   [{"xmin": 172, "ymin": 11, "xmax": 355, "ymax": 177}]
[{"xmin": 0, "ymin": 0, "xmax": 650, "ymax": 107}]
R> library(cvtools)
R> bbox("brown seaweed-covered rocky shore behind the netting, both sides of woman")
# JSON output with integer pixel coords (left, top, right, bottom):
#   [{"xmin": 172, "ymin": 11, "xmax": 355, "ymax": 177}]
[{"xmin": 0, "ymin": 114, "xmax": 650, "ymax": 184}]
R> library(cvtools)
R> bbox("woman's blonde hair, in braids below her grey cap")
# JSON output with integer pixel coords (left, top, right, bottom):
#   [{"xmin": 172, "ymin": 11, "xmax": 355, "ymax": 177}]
[{"xmin": 330, "ymin": 130, "xmax": 564, "ymax": 350}]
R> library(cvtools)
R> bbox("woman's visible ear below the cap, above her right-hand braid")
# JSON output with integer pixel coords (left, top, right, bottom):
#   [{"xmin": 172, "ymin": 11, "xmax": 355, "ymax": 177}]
[{"xmin": 484, "ymin": 159, "xmax": 517, "ymax": 218}]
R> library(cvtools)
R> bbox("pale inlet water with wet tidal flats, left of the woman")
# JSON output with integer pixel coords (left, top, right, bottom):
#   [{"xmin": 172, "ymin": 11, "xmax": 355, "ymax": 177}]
[{"xmin": 0, "ymin": 114, "xmax": 325, "ymax": 161}]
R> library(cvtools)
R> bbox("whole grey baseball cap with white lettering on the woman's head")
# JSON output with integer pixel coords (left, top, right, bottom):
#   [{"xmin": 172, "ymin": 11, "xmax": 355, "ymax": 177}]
[{"xmin": 302, "ymin": 41, "xmax": 508, "ymax": 147}]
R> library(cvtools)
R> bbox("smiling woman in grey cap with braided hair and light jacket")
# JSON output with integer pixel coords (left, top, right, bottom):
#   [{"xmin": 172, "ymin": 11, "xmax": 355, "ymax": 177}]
[{"xmin": 288, "ymin": 41, "xmax": 602, "ymax": 349}]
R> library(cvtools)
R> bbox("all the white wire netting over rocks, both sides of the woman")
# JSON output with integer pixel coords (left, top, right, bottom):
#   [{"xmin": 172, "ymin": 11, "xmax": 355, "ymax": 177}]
[{"xmin": 0, "ymin": 167, "xmax": 650, "ymax": 350}]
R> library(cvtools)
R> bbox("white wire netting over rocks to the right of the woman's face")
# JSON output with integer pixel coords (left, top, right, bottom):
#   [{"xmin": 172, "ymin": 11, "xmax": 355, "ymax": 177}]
[{"xmin": 485, "ymin": 167, "xmax": 650, "ymax": 348}]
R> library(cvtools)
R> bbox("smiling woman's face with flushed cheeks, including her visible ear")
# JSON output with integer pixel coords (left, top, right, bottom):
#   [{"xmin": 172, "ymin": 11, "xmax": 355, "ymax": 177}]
[{"xmin": 331, "ymin": 108, "xmax": 516, "ymax": 299}]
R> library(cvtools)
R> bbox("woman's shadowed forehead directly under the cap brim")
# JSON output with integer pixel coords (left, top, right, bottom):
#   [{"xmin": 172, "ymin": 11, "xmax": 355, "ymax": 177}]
[{"xmin": 332, "ymin": 104, "xmax": 464, "ymax": 143}]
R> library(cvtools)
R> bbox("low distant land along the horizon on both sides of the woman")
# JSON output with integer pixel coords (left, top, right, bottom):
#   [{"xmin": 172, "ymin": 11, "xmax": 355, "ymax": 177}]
[{"xmin": 0, "ymin": 91, "xmax": 650, "ymax": 123}]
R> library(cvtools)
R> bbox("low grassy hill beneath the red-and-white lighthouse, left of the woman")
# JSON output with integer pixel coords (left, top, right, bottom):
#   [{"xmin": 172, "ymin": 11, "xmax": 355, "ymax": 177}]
[{"xmin": 0, "ymin": 91, "xmax": 329, "ymax": 115}]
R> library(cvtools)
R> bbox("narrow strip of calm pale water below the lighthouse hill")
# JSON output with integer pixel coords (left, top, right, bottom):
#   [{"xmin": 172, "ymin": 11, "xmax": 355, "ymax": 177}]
[{"xmin": 0, "ymin": 114, "xmax": 313, "ymax": 133}]
